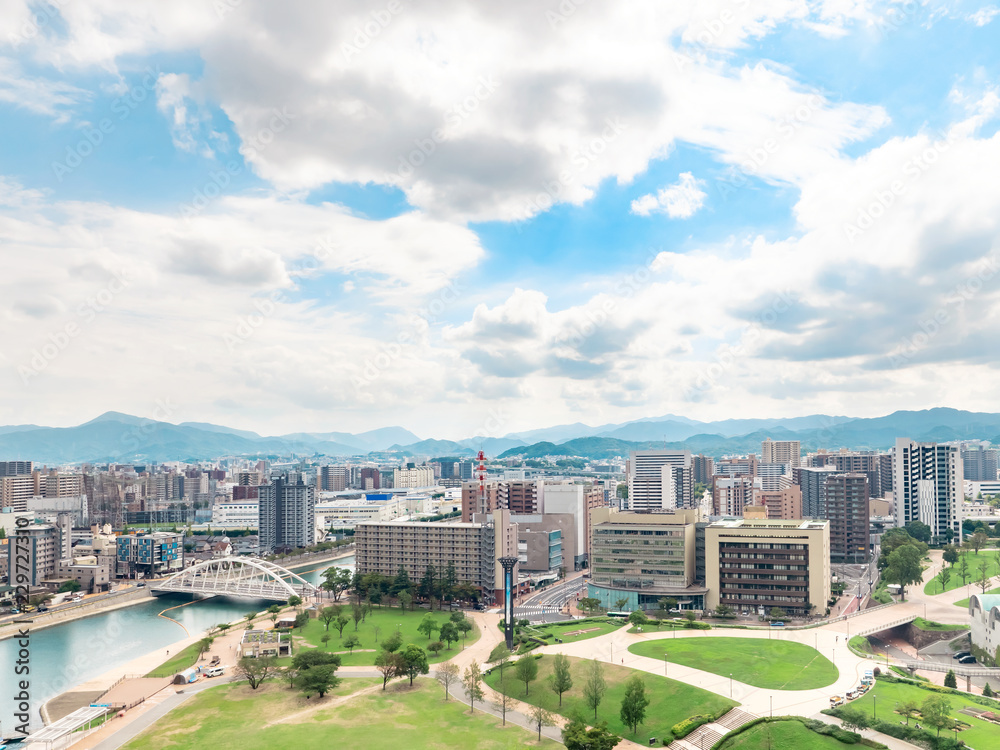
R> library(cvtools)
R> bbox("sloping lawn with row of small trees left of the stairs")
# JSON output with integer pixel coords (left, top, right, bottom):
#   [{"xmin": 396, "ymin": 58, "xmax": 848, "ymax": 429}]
[{"xmin": 485, "ymin": 654, "xmax": 739, "ymax": 737}]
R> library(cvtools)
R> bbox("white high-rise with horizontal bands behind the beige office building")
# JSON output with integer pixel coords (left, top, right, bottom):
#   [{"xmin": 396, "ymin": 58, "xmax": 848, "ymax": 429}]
[{"xmin": 628, "ymin": 450, "xmax": 694, "ymax": 510}]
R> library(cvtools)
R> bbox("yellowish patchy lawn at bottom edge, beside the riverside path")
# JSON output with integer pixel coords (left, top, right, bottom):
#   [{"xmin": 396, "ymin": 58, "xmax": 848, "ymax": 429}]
[{"xmin": 125, "ymin": 678, "xmax": 562, "ymax": 750}]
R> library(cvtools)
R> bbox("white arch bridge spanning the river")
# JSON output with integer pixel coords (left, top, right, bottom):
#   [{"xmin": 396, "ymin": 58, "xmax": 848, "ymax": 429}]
[{"xmin": 151, "ymin": 557, "xmax": 319, "ymax": 602}]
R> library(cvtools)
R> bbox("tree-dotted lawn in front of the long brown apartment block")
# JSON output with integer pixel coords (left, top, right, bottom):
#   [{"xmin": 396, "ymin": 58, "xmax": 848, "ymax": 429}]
[{"xmin": 294, "ymin": 606, "xmax": 479, "ymax": 667}]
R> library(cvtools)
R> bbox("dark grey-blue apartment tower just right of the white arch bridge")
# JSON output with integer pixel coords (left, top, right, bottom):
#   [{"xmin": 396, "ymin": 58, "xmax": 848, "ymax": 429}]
[{"xmin": 257, "ymin": 477, "xmax": 316, "ymax": 551}]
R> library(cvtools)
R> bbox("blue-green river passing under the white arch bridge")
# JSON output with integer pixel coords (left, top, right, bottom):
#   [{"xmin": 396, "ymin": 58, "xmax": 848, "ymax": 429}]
[{"xmin": 0, "ymin": 556, "xmax": 354, "ymax": 735}]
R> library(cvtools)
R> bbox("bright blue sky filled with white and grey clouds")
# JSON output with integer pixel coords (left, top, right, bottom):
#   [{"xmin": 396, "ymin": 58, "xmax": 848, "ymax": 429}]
[{"xmin": 0, "ymin": 0, "xmax": 1000, "ymax": 439}]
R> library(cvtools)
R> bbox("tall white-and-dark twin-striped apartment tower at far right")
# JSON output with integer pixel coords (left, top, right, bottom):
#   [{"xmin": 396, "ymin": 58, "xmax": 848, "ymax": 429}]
[{"xmin": 893, "ymin": 438, "xmax": 964, "ymax": 541}]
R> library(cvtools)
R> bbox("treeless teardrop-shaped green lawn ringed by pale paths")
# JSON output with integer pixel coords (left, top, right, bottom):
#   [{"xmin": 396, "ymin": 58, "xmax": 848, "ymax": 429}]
[{"xmin": 628, "ymin": 637, "xmax": 839, "ymax": 690}]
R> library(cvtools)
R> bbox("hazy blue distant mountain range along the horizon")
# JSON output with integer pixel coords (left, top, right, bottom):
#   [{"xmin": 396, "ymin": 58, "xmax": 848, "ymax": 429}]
[{"xmin": 0, "ymin": 408, "xmax": 1000, "ymax": 465}]
